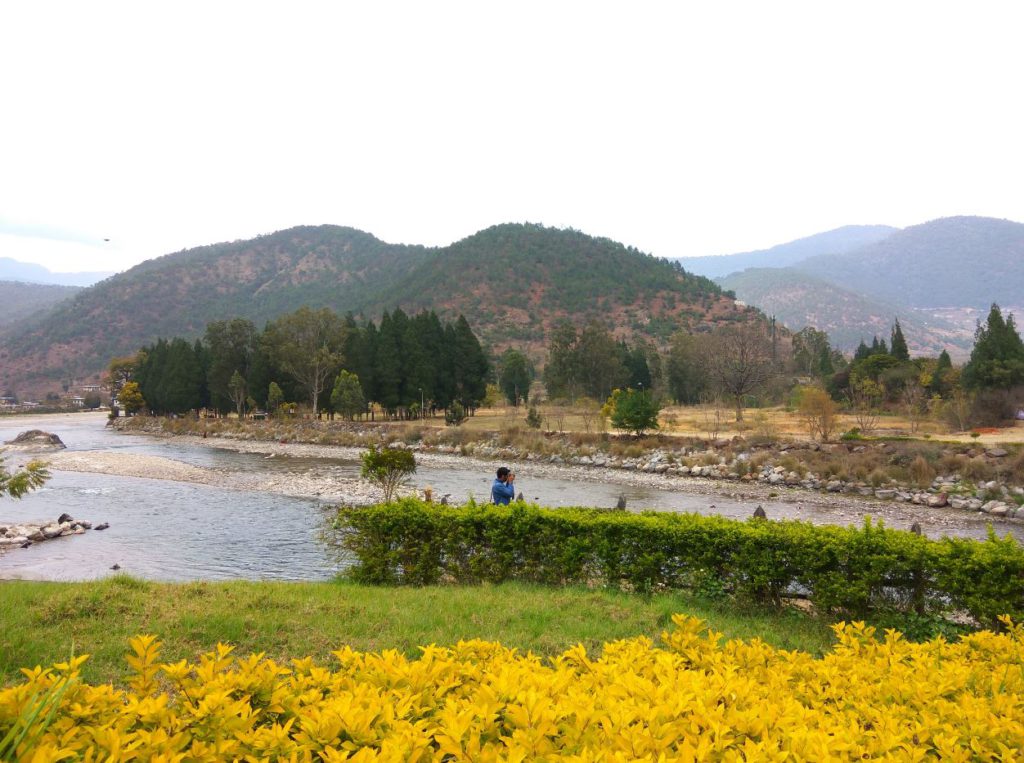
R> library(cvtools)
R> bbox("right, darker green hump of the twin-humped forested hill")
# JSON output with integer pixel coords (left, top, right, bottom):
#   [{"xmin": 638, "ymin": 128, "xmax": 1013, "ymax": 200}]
[{"xmin": 364, "ymin": 224, "xmax": 737, "ymax": 345}]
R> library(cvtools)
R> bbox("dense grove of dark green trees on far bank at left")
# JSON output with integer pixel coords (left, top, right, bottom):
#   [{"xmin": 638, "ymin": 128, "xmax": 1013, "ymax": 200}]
[{"xmin": 110, "ymin": 307, "xmax": 490, "ymax": 418}]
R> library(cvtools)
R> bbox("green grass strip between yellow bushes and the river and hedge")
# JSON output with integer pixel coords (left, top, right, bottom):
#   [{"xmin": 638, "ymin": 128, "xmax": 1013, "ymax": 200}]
[{"xmin": 0, "ymin": 577, "xmax": 833, "ymax": 685}]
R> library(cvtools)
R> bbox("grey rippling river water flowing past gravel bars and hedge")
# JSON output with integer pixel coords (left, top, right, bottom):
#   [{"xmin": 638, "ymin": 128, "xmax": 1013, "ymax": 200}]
[{"xmin": 0, "ymin": 414, "xmax": 1024, "ymax": 581}]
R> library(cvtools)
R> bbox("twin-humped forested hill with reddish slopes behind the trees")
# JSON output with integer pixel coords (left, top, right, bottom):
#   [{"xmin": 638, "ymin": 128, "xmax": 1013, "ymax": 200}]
[{"xmin": 0, "ymin": 219, "xmax": 746, "ymax": 389}]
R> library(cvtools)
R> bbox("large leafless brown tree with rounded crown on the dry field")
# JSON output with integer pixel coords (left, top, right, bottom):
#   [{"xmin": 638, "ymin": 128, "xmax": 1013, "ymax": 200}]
[{"xmin": 703, "ymin": 324, "xmax": 773, "ymax": 421}]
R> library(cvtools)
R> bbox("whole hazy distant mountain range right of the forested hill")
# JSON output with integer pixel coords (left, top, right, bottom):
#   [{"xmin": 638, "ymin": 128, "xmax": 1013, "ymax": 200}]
[{"xmin": 681, "ymin": 217, "xmax": 1024, "ymax": 358}]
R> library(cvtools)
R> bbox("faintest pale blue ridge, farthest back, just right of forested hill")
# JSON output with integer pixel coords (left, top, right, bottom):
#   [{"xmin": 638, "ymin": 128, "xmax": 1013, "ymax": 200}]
[{"xmin": 679, "ymin": 225, "xmax": 899, "ymax": 279}]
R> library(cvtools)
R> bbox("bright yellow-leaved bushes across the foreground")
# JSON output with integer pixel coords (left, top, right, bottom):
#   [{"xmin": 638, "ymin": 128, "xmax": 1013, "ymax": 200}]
[{"xmin": 0, "ymin": 616, "xmax": 1024, "ymax": 763}]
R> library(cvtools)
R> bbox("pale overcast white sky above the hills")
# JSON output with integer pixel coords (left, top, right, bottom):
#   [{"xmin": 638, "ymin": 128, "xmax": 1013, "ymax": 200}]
[{"xmin": 0, "ymin": 0, "xmax": 1024, "ymax": 270}]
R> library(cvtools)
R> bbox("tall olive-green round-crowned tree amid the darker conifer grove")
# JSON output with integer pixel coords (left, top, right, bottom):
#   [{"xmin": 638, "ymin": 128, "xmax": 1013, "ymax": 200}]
[{"xmin": 263, "ymin": 307, "xmax": 345, "ymax": 416}]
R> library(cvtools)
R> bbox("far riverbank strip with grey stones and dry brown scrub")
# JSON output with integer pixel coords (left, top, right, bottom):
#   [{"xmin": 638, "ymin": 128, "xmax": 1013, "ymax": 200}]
[{"xmin": 115, "ymin": 417, "xmax": 1024, "ymax": 525}]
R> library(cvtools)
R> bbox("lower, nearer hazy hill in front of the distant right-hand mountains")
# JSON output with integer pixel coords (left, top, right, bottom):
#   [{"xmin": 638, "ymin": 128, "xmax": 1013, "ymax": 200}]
[{"xmin": 717, "ymin": 267, "xmax": 974, "ymax": 359}]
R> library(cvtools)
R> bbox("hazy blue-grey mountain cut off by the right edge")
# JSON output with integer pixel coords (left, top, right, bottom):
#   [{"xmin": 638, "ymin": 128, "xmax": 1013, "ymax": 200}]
[{"xmin": 797, "ymin": 217, "xmax": 1024, "ymax": 309}]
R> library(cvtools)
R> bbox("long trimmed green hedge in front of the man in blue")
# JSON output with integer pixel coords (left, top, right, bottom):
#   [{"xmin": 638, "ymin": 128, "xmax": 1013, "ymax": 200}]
[{"xmin": 335, "ymin": 499, "xmax": 1024, "ymax": 626}]
